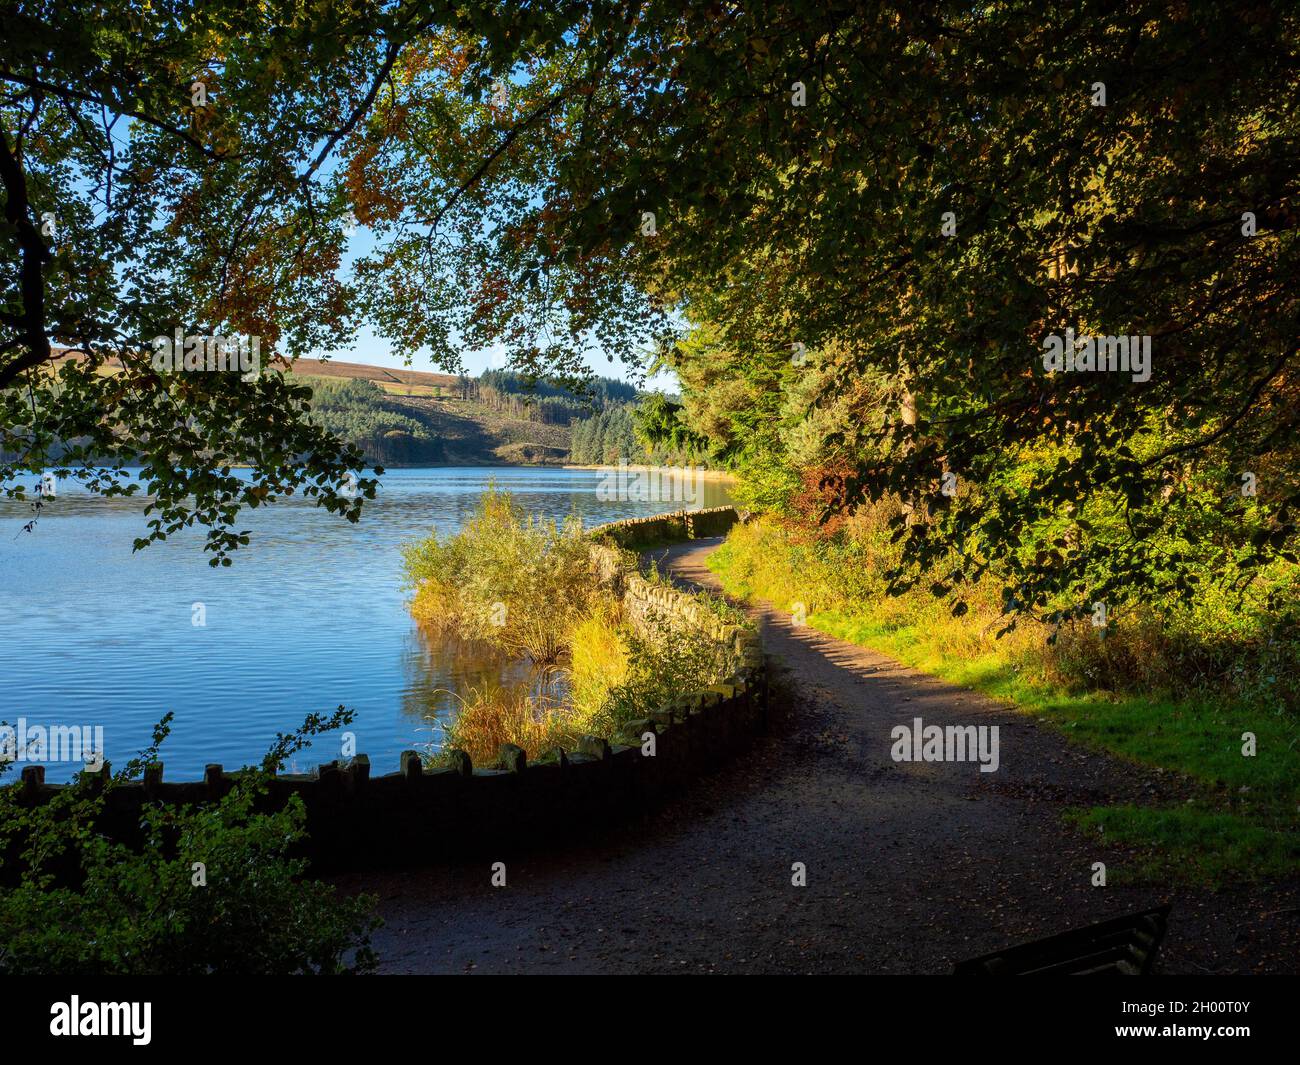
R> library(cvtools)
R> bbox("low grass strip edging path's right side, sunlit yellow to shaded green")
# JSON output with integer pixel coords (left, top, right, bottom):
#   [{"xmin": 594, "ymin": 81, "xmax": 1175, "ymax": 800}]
[{"xmin": 709, "ymin": 533, "xmax": 1300, "ymax": 887}]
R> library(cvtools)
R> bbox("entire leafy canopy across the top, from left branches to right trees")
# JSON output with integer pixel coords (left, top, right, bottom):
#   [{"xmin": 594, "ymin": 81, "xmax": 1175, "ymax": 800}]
[{"xmin": 0, "ymin": 0, "xmax": 1300, "ymax": 608}]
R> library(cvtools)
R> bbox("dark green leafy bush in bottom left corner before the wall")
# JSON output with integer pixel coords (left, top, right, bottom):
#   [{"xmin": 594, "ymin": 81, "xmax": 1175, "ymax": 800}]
[{"xmin": 0, "ymin": 711, "xmax": 377, "ymax": 975}]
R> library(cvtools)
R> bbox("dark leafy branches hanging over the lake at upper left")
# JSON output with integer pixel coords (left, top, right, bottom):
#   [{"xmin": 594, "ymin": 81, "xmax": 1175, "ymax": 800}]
[{"xmin": 0, "ymin": 0, "xmax": 587, "ymax": 564}]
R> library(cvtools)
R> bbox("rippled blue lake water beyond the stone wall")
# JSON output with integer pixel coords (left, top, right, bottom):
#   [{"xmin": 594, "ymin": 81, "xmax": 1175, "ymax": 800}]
[{"xmin": 0, "ymin": 467, "xmax": 731, "ymax": 782}]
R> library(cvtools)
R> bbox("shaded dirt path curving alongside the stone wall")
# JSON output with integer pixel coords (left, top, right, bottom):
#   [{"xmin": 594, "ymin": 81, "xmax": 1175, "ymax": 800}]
[{"xmin": 341, "ymin": 541, "xmax": 1300, "ymax": 973}]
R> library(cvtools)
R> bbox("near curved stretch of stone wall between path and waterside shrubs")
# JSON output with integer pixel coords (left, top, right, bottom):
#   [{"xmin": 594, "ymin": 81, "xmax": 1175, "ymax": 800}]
[{"xmin": 10, "ymin": 511, "xmax": 768, "ymax": 871}]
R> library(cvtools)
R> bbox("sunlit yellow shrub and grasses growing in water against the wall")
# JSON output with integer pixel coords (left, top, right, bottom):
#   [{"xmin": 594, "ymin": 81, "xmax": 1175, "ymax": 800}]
[{"xmin": 404, "ymin": 485, "xmax": 744, "ymax": 766}]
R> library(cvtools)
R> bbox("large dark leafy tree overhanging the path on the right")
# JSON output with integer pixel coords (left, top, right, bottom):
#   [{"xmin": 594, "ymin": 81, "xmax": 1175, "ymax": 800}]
[{"xmin": 343, "ymin": 0, "xmax": 1300, "ymax": 616}]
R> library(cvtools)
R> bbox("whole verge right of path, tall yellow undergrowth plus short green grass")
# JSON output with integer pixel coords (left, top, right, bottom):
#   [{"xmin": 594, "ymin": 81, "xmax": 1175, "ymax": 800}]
[{"xmin": 709, "ymin": 512, "xmax": 1300, "ymax": 884}]
